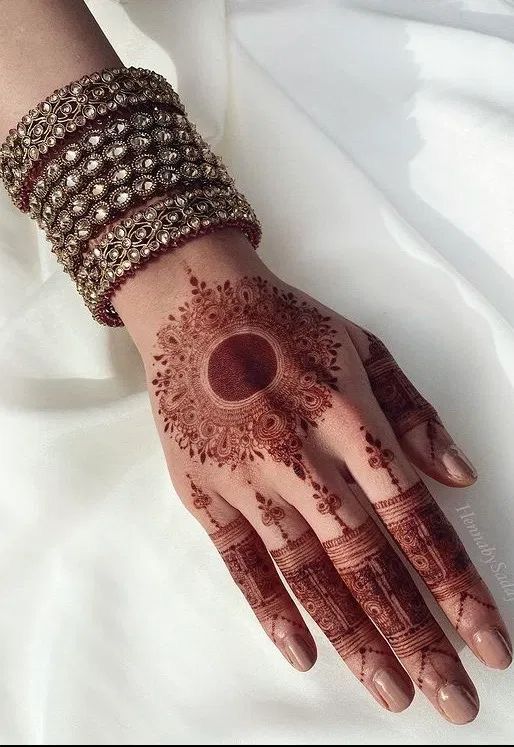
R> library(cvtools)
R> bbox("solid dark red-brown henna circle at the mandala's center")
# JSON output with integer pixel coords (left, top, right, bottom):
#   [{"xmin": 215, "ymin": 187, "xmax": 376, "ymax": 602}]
[{"xmin": 207, "ymin": 332, "xmax": 277, "ymax": 402}]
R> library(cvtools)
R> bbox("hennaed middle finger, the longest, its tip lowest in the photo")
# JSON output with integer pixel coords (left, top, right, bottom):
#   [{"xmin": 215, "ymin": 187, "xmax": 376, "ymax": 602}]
[{"xmin": 274, "ymin": 455, "xmax": 478, "ymax": 723}]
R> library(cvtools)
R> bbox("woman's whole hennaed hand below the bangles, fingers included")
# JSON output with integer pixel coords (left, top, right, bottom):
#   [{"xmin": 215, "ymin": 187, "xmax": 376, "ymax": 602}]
[{"xmin": 114, "ymin": 231, "xmax": 511, "ymax": 723}]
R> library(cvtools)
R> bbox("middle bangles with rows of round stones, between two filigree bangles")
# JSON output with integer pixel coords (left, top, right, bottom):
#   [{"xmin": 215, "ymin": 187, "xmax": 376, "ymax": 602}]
[{"xmin": 37, "ymin": 110, "xmax": 232, "ymax": 277}]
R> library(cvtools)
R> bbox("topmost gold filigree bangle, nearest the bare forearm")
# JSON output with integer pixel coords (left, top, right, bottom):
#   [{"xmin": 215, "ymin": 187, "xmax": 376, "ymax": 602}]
[{"xmin": 0, "ymin": 67, "xmax": 184, "ymax": 211}]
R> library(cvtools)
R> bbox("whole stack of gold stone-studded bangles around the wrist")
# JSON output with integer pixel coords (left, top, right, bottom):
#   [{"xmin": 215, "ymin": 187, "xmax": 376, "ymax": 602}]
[{"xmin": 0, "ymin": 68, "xmax": 260, "ymax": 326}]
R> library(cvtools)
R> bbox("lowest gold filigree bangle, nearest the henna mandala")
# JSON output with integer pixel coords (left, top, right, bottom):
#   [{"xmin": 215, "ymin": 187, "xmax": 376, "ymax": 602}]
[{"xmin": 77, "ymin": 187, "xmax": 261, "ymax": 327}]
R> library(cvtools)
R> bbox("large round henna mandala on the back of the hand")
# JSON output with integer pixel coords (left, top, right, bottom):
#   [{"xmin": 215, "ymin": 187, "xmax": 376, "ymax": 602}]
[{"xmin": 152, "ymin": 276, "xmax": 340, "ymax": 470}]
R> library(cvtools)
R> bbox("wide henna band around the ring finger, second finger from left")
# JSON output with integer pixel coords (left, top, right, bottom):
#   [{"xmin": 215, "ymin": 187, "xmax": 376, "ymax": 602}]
[{"xmin": 271, "ymin": 529, "xmax": 376, "ymax": 657}]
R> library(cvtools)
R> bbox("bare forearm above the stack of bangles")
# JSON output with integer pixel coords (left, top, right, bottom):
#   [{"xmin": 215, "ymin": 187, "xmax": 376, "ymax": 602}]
[{"xmin": 0, "ymin": 0, "xmax": 120, "ymax": 138}]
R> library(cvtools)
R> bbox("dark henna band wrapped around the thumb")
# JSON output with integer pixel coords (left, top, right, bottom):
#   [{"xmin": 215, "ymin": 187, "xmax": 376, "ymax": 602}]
[{"xmin": 364, "ymin": 332, "xmax": 440, "ymax": 436}]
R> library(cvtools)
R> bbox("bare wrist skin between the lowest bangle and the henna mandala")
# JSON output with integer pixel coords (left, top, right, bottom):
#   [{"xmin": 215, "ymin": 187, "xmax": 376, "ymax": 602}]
[{"xmin": 112, "ymin": 228, "xmax": 269, "ymax": 356}]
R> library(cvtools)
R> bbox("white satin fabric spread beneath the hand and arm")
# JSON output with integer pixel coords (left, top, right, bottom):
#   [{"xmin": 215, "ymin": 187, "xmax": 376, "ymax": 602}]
[{"xmin": 0, "ymin": 0, "xmax": 514, "ymax": 744}]
